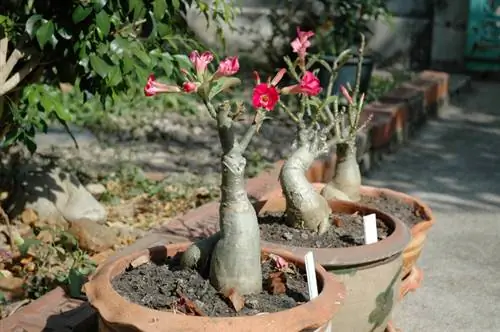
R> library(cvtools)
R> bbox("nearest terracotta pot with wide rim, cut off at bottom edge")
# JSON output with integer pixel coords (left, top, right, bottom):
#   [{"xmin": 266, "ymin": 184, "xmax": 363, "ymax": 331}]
[{"xmin": 84, "ymin": 243, "xmax": 345, "ymax": 332}]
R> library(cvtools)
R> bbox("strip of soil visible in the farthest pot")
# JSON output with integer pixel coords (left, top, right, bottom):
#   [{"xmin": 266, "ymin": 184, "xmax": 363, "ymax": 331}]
[{"xmin": 358, "ymin": 194, "xmax": 428, "ymax": 228}]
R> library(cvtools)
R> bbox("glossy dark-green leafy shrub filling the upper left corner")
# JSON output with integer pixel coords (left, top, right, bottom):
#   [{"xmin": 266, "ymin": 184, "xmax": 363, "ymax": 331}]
[{"xmin": 0, "ymin": 0, "xmax": 236, "ymax": 151}]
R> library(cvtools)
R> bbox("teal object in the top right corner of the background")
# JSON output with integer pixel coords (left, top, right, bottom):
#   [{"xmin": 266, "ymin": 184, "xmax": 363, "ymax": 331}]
[{"xmin": 465, "ymin": 0, "xmax": 500, "ymax": 72}]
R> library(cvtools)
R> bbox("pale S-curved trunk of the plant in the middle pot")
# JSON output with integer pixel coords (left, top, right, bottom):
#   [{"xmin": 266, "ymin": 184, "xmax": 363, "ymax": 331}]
[{"xmin": 280, "ymin": 128, "xmax": 331, "ymax": 234}]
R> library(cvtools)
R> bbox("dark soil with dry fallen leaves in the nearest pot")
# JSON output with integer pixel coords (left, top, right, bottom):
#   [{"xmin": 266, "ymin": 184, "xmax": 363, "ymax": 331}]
[{"xmin": 112, "ymin": 254, "xmax": 309, "ymax": 317}]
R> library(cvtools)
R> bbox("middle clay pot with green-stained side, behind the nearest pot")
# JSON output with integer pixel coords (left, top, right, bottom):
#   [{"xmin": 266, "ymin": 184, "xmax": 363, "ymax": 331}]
[{"xmin": 256, "ymin": 191, "xmax": 410, "ymax": 332}]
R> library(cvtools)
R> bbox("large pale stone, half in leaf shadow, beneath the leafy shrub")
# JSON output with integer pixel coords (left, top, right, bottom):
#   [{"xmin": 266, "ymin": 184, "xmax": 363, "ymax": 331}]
[{"xmin": 7, "ymin": 165, "xmax": 107, "ymax": 224}]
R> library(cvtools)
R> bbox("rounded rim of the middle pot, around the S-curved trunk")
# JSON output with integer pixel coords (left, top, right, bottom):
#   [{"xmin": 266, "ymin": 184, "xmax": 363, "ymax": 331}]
[{"xmin": 260, "ymin": 183, "xmax": 411, "ymax": 267}]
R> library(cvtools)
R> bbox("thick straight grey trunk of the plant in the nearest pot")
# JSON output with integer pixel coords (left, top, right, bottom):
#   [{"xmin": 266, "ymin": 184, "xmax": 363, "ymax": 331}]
[{"xmin": 182, "ymin": 110, "xmax": 262, "ymax": 295}]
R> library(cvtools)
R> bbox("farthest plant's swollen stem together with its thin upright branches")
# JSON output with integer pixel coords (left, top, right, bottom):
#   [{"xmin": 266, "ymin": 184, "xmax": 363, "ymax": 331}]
[{"xmin": 321, "ymin": 35, "xmax": 370, "ymax": 201}]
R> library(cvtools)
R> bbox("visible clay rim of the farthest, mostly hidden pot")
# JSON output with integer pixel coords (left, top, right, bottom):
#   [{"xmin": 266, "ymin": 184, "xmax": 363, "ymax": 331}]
[{"xmin": 361, "ymin": 186, "xmax": 436, "ymax": 235}]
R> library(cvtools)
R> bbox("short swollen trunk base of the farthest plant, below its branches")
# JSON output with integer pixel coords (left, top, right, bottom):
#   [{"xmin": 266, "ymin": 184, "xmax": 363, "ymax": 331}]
[{"xmin": 321, "ymin": 143, "xmax": 361, "ymax": 202}]
